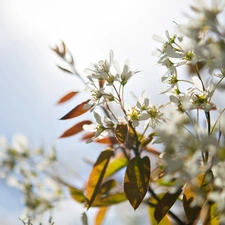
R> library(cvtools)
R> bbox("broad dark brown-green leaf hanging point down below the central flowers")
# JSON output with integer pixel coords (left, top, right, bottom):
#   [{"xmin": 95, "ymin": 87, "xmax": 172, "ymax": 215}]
[{"xmin": 124, "ymin": 156, "xmax": 150, "ymax": 209}]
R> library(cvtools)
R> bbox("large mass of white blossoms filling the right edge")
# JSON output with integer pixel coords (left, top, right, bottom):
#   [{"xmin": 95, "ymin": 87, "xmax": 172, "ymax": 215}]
[{"xmin": 150, "ymin": 1, "xmax": 225, "ymax": 224}]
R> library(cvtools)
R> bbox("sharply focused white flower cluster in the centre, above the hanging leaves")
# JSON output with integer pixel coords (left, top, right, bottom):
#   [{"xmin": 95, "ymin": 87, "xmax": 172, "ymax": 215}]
[{"xmin": 83, "ymin": 50, "xmax": 165, "ymax": 143}]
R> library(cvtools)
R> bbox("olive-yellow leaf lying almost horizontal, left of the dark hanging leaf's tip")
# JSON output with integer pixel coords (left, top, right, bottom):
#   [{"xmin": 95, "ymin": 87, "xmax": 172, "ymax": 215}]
[{"xmin": 92, "ymin": 192, "xmax": 127, "ymax": 207}]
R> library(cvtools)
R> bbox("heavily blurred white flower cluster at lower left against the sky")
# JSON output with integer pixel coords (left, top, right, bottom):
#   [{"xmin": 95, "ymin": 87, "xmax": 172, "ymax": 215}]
[{"xmin": 0, "ymin": 134, "xmax": 62, "ymax": 213}]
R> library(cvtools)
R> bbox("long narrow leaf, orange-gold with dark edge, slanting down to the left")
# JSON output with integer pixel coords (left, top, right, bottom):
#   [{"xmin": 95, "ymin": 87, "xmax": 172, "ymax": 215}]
[{"xmin": 86, "ymin": 149, "xmax": 114, "ymax": 209}]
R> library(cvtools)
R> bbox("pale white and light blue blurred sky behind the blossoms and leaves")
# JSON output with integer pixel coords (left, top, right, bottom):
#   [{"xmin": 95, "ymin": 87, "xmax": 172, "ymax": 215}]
[{"xmin": 0, "ymin": 0, "xmax": 192, "ymax": 225}]
